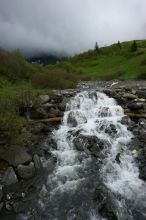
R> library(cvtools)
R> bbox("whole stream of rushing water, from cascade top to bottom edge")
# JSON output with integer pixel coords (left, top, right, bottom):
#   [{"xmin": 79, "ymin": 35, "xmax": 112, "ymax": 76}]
[{"xmin": 20, "ymin": 90, "xmax": 146, "ymax": 220}]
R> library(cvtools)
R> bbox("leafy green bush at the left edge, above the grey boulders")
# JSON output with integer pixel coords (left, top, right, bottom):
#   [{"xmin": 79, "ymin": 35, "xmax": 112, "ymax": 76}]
[{"xmin": 0, "ymin": 89, "xmax": 30, "ymax": 146}]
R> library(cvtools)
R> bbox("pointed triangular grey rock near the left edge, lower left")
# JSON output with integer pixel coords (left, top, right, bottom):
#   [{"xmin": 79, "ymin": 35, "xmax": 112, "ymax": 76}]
[{"xmin": 2, "ymin": 167, "xmax": 18, "ymax": 185}]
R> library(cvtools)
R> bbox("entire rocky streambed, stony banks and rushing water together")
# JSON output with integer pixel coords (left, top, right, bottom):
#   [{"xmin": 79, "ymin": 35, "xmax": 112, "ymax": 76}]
[{"xmin": 0, "ymin": 81, "xmax": 146, "ymax": 220}]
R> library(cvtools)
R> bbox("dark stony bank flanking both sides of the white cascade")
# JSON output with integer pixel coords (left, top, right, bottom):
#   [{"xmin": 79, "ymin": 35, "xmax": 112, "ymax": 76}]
[{"xmin": 0, "ymin": 81, "xmax": 146, "ymax": 219}]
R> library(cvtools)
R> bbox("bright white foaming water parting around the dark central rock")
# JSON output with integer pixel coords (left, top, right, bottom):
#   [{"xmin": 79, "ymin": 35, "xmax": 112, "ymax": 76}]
[{"xmin": 51, "ymin": 91, "xmax": 145, "ymax": 203}]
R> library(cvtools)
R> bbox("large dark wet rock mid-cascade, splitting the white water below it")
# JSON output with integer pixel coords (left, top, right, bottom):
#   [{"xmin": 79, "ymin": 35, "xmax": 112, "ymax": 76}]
[{"xmin": 73, "ymin": 134, "xmax": 104, "ymax": 156}]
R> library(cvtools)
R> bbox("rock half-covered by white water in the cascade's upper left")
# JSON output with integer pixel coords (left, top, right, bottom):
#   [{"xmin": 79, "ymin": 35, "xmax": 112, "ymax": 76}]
[{"xmin": 67, "ymin": 111, "xmax": 87, "ymax": 127}]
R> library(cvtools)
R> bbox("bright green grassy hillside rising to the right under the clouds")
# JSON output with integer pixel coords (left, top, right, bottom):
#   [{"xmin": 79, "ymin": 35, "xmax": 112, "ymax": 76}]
[{"xmin": 56, "ymin": 40, "xmax": 146, "ymax": 80}]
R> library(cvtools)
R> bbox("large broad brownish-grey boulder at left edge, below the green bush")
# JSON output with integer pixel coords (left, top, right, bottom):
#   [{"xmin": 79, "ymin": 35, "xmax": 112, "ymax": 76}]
[{"xmin": 0, "ymin": 146, "xmax": 32, "ymax": 166}]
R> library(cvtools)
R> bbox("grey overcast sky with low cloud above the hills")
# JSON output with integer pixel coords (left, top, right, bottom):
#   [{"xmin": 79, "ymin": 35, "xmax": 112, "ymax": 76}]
[{"xmin": 0, "ymin": 0, "xmax": 146, "ymax": 54}]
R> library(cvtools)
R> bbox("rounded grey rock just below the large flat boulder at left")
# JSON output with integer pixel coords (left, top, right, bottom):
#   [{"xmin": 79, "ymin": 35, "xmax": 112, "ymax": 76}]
[{"xmin": 17, "ymin": 162, "xmax": 35, "ymax": 179}]
